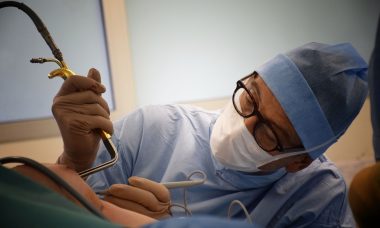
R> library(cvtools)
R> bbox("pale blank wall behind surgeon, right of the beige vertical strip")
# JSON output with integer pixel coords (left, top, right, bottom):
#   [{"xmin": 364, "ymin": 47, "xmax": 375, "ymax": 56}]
[{"xmin": 125, "ymin": 0, "xmax": 380, "ymax": 106}]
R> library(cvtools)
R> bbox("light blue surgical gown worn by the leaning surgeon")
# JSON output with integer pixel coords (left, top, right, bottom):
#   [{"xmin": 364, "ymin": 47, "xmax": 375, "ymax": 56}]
[{"xmin": 88, "ymin": 105, "xmax": 354, "ymax": 227}]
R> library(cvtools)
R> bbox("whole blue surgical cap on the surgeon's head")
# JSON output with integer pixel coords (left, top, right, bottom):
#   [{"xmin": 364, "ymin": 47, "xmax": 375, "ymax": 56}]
[{"xmin": 256, "ymin": 43, "xmax": 368, "ymax": 159}]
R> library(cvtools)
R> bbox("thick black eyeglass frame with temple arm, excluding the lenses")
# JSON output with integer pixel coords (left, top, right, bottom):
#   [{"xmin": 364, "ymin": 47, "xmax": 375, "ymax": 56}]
[{"xmin": 232, "ymin": 71, "xmax": 304, "ymax": 153}]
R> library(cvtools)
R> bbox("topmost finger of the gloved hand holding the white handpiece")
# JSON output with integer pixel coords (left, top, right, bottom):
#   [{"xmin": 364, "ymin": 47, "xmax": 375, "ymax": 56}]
[{"xmin": 128, "ymin": 176, "xmax": 170, "ymax": 202}]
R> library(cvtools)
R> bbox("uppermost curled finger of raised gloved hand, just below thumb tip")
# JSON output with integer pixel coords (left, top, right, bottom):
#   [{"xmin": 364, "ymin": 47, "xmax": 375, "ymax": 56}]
[{"xmin": 56, "ymin": 75, "xmax": 106, "ymax": 96}]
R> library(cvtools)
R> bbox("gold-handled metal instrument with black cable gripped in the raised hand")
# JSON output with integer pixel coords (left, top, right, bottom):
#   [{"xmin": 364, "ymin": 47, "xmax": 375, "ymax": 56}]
[{"xmin": 0, "ymin": 1, "xmax": 119, "ymax": 178}]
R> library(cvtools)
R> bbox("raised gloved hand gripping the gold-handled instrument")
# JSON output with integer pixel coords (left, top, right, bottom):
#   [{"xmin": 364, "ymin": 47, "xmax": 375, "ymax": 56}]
[{"xmin": 52, "ymin": 69, "xmax": 113, "ymax": 171}]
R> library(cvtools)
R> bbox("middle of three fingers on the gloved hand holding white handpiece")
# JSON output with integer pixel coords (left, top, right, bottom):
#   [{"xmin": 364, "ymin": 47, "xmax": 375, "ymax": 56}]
[{"xmin": 106, "ymin": 184, "xmax": 169, "ymax": 211}]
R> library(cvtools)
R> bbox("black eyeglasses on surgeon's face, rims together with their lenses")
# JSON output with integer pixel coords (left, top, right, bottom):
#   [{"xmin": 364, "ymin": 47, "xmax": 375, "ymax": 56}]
[{"xmin": 232, "ymin": 72, "xmax": 284, "ymax": 152}]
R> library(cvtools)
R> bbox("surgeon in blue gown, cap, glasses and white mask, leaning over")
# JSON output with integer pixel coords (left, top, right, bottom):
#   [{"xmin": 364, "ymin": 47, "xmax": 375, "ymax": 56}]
[{"xmin": 52, "ymin": 43, "xmax": 368, "ymax": 227}]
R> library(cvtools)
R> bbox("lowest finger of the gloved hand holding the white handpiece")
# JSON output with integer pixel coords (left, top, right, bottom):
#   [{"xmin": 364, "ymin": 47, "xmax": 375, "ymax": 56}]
[{"xmin": 104, "ymin": 195, "xmax": 170, "ymax": 219}]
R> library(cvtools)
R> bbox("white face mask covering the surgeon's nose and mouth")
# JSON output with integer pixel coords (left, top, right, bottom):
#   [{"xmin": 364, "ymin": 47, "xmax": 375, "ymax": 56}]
[{"xmin": 210, "ymin": 97, "xmax": 306, "ymax": 172}]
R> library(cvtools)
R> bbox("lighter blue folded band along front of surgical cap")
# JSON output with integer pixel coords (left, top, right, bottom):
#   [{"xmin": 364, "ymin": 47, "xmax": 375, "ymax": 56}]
[{"xmin": 256, "ymin": 54, "xmax": 336, "ymax": 159}]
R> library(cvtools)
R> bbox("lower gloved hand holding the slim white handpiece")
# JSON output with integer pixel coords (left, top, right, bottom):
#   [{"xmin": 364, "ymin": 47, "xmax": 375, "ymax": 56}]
[{"xmin": 103, "ymin": 176, "xmax": 170, "ymax": 219}]
